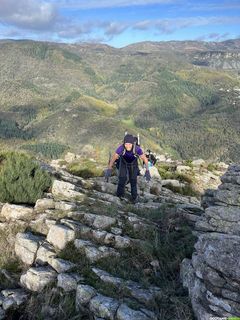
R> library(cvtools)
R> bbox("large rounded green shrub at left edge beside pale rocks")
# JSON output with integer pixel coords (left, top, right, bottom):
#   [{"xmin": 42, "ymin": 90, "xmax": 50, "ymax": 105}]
[{"xmin": 0, "ymin": 152, "xmax": 51, "ymax": 204}]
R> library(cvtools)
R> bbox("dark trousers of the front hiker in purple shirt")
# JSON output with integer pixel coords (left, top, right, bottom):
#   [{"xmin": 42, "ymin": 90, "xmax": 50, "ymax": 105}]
[{"xmin": 117, "ymin": 156, "xmax": 139, "ymax": 199}]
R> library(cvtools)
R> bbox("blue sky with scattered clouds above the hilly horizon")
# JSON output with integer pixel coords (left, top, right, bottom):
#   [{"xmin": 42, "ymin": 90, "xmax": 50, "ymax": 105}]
[{"xmin": 0, "ymin": 0, "xmax": 240, "ymax": 48}]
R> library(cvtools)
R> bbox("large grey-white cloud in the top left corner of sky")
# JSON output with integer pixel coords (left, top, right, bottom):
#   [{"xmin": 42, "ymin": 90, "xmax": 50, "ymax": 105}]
[{"xmin": 0, "ymin": 0, "xmax": 57, "ymax": 30}]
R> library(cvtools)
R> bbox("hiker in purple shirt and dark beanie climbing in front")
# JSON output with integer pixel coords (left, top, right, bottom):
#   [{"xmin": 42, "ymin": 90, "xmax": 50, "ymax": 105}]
[{"xmin": 105, "ymin": 134, "xmax": 151, "ymax": 203}]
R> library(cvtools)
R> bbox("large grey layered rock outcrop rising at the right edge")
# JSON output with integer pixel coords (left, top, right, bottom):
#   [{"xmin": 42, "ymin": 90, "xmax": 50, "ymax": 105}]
[{"xmin": 181, "ymin": 165, "xmax": 240, "ymax": 320}]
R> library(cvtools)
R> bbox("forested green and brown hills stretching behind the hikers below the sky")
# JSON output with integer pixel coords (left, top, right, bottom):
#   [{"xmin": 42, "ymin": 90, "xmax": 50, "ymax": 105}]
[{"xmin": 0, "ymin": 40, "xmax": 240, "ymax": 161}]
